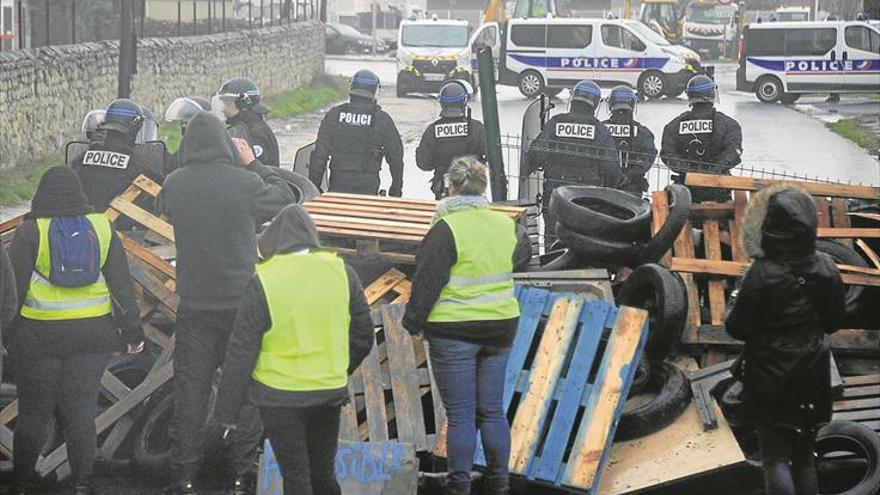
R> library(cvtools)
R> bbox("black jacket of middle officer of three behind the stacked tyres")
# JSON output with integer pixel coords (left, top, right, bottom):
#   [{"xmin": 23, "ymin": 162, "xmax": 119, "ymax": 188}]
[{"xmin": 602, "ymin": 115, "xmax": 657, "ymax": 192}]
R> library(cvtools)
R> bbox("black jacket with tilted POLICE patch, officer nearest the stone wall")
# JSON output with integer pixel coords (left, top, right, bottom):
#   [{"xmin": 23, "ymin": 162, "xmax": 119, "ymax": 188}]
[{"xmin": 72, "ymin": 131, "xmax": 165, "ymax": 212}]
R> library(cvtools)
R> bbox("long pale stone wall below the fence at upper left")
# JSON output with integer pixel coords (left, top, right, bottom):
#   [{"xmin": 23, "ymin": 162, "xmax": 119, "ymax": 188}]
[{"xmin": 0, "ymin": 21, "xmax": 324, "ymax": 170}]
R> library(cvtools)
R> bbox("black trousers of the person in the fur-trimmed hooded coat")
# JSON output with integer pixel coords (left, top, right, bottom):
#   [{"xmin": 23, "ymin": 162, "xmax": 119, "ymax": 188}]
[{"xmin": 757, "ymin": 424, "xmax": 819, "ymax": 495}]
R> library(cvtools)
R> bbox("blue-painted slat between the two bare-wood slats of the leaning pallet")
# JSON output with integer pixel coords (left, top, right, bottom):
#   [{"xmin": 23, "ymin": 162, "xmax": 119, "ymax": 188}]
[{"xmin": 529, "ymin": 300, "xmax": 608, "ymax": 483}]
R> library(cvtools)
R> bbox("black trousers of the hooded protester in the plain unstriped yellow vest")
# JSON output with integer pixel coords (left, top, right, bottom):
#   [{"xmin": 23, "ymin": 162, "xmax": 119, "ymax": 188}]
[{"xmin": 260, "ymin": 406, "xmax": 342, "ymax": 495}]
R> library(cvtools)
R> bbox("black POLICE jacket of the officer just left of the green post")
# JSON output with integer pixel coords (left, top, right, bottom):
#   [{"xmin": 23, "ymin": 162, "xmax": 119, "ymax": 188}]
[{"xmin": 416, "ymin": 117, "xmax": 486, "ymax": 194}]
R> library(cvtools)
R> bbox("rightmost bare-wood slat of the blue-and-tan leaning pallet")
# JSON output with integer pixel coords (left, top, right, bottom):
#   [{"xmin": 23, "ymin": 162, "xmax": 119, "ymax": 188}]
[{"xmin": 560, "ymin": 306, "xmax": 648, "ymax": 490}]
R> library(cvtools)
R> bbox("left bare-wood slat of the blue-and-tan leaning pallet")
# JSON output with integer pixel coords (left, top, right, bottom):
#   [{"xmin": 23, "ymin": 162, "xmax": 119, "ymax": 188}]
[{"xmin": 510, "ymin": 297, "xmax": 584, "ymax": 474}]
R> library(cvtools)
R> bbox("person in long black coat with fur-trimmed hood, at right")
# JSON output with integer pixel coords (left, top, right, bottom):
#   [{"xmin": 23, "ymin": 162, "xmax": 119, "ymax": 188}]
[{"xmin": 725, "ymin": 186, "xmax": 846, "ymax": 495}]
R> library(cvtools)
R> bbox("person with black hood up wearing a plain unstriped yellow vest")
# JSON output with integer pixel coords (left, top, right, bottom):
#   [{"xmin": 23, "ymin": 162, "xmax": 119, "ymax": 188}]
[{"xmin": 215, "ymin": 205, "xmax": 373, "ymax": 495}]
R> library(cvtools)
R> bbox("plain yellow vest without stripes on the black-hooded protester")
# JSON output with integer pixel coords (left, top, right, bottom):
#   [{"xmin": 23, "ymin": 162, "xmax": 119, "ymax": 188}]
[{"xmin": 252, "ymin": 252, "xmax": 351, "ymax": 392}]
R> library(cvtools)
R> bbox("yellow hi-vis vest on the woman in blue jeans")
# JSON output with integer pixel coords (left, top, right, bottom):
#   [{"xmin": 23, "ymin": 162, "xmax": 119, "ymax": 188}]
[{"xmin": 428, "ymin": 208, "xmax": 519, "ymax": 323}]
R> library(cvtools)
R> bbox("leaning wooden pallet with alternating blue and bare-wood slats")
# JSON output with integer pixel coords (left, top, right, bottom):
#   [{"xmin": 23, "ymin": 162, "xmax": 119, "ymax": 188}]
[{"xmin": 435, "ymin": 286, "xmax": 647, "ymax": 491}]
